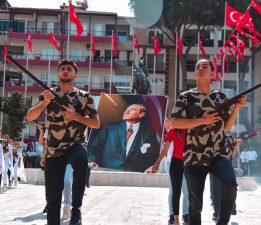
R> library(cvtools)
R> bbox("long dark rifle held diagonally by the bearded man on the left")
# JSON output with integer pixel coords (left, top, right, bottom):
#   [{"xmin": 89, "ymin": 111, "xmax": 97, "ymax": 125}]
[{"xmin": 6, "ymin": 55, "xmax": 63, "ymax": 108}]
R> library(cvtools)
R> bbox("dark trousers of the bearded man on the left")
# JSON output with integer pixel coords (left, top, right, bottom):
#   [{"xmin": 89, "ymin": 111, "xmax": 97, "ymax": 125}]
[{"xmin": 45, "ymin": 144, "xmax": 88, "ymax": 225}]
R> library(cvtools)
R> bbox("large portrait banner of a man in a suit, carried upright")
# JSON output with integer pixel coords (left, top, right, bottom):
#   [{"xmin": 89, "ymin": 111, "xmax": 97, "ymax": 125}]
[{"xmin": 87, "ymin": 94, "xmax": 168, "ymax": 172}]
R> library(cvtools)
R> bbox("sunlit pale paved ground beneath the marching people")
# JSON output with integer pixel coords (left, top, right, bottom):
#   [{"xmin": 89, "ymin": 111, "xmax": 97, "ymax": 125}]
[{"xmin": 0, "ymin": 178, "xmax": 261, "ymax": 225}]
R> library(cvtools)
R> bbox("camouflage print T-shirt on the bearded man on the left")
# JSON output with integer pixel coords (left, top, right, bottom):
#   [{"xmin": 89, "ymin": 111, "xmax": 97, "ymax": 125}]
[{"xmin": 39, "ymin": 86, "xmax": 97, "ymax": 157}]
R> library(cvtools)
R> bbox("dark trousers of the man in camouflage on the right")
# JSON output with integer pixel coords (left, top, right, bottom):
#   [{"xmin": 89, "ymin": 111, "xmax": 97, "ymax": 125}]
[{"xmin": 184, "ymin": 157, "xmax": 237, "ymax": 225}]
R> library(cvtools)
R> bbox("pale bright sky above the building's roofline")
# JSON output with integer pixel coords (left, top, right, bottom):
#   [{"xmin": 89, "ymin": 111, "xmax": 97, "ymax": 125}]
[{"xmin": 8, "ymin": 0, "xmax": 133, "ymax": 16}]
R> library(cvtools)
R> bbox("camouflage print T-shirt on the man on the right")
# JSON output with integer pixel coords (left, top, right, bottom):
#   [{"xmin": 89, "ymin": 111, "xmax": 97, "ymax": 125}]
[{"xmin": 171, "ymin": 89, "xmax": 228, "ymax": 166}]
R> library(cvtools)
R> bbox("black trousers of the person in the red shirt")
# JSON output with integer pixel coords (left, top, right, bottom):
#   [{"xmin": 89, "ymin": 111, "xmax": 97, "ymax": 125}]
[{"xmin": 169, "ymin": 157, "xmax": 184, "ymax": 215}]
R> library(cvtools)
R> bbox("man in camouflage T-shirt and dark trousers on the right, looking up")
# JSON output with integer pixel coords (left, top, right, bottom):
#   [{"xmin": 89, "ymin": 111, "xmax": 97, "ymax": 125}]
[{"xmin": 171, "ymin": 59, "xmax": 246, "ymax": 225}]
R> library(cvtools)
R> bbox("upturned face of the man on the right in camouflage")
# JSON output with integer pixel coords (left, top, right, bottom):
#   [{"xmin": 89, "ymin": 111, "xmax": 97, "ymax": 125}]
[{"xmin": 194, "ymin": 59, "xmax": 214, "ymax": 82}]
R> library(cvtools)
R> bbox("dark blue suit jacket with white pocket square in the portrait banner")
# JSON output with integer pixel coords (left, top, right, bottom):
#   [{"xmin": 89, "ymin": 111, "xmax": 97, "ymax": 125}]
[{"xmin": 88, "ymin": 121, "xmax": 160, "ymax": 172}]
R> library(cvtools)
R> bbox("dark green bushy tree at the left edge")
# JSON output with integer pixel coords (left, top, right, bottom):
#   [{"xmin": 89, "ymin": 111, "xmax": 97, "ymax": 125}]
[{"xmin": 2, "ymin": 92, "xmax": 27, "ymax": 138}]
